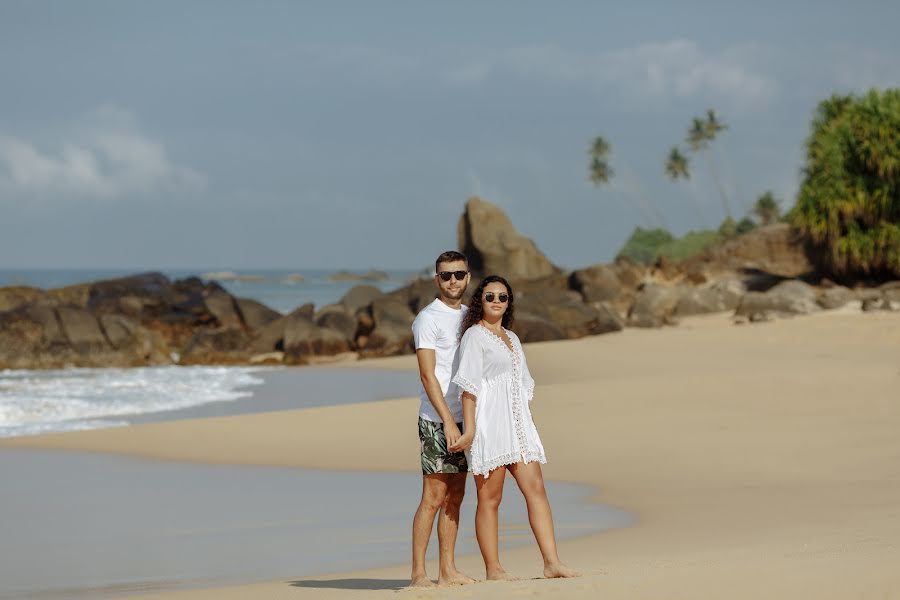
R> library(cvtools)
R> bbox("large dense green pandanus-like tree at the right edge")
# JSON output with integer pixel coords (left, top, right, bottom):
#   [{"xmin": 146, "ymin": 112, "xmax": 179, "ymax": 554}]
[{"xmin": 789, "ymin": 89, "xmax": 900, "ymax": 277}]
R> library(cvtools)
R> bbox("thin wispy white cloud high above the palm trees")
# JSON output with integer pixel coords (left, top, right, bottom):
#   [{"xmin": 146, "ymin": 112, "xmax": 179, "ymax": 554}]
[{"xmin": 444, "ymin": 40, "xmax": 776, "ymax": 105}]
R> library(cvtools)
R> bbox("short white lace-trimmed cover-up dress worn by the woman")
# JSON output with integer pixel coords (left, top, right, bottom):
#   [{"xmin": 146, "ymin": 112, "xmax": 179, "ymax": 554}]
[{"xmin": 452, "ymin": 325, "xmax": 547, "ymax": 477}]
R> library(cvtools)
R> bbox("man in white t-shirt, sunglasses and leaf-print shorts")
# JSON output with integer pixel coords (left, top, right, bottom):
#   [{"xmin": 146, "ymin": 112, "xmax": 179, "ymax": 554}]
[{"xmin": 410, "ymin": 251, "xmax": 474, "ymax": 587}]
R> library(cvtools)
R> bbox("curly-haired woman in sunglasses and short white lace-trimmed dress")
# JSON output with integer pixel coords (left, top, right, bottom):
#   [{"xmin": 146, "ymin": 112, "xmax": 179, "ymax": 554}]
[{"xmin": 451, "ymin": 275, "xmax": 581, "ymax": 579}]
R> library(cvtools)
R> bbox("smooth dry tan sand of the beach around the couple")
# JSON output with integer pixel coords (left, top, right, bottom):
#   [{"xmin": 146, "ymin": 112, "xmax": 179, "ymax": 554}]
[{"xmin": 0, "ymin": 310, "xmax": 900, "ymax": 599}]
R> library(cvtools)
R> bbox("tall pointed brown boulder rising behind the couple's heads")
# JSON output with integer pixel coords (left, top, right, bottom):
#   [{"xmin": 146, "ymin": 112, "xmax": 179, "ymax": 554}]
[{"xmin": 457, "ymin": 198, "xmax": 560, "ymax": 279}]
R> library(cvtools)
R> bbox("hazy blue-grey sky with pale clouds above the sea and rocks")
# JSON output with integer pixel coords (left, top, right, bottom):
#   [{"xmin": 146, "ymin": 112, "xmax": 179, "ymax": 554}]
[{"xmin": 0, "ymin": 0, "xmax": 900, "ymax": 269}]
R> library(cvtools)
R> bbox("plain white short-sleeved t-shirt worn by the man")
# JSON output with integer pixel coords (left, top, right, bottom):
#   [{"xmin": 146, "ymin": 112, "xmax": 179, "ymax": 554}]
[{"xmin": 413, "ymin": 298, "xmax": 468, "ymax": 423}]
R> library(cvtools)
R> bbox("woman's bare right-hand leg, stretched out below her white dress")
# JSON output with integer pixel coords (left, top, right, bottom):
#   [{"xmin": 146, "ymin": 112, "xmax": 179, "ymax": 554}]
[{"xmin": 510, "ymin": 462, "xmax": 581, "ymax": 577}]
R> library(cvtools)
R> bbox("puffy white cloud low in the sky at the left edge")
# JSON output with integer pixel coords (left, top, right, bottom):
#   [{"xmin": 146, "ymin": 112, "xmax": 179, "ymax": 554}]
[{"xmin": 0, "ymin": 108, "xmax": 206, "ymax": 200}]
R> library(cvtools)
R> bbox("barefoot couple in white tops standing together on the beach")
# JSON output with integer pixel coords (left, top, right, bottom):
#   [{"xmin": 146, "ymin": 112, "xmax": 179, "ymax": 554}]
[{"xmin": 410, "ymin": 251, "xmax": 580, "ymax": 587}]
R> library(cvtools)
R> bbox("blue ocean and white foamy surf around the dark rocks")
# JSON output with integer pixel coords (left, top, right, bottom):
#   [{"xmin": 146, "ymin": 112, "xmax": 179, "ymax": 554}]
[{"xmin": 0, "ymin": 269, "xmax": 426, "ymax": 437}]
